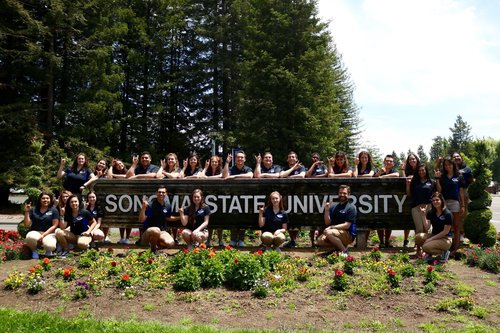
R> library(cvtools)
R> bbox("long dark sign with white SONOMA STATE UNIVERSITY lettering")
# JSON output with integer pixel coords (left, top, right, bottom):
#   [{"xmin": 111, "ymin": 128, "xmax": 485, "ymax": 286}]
[{"xmin": 94, "ymin": 178, "xmax": 413, "ymax": 229}]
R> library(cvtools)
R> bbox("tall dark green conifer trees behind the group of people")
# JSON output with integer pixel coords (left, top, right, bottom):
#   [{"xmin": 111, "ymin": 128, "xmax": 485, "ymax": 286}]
[{"xmin": 0, "ymin": 0, "xmax": 500, "ymax": 203}]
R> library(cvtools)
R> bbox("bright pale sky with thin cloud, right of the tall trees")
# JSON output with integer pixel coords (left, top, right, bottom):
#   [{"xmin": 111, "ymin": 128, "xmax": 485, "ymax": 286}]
[{"xmin": 318, "ymin": 0, "xmax": 500, "ymax": 155}]
